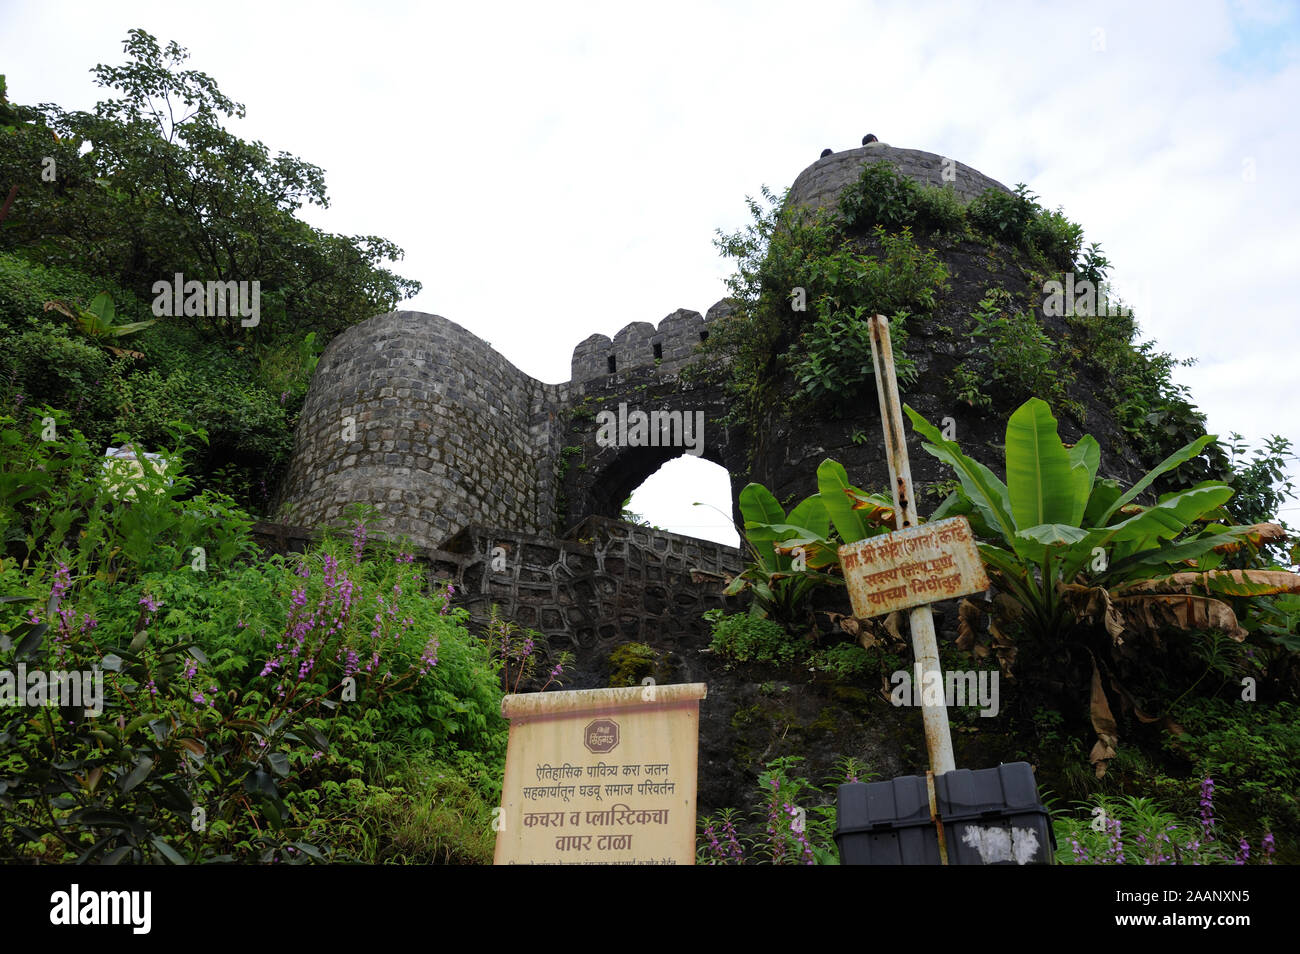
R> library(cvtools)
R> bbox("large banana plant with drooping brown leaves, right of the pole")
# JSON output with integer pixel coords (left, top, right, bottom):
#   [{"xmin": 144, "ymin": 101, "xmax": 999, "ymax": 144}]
[{"xmin": 904, "ymin": 398, "xmax": 1300, "ymax": 777}]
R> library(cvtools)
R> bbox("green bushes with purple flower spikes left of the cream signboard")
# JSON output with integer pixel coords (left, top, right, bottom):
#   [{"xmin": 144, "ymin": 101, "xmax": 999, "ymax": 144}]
[{"xmin": 0, "ymin": 412, "xmax": 506, "ymax": 863}]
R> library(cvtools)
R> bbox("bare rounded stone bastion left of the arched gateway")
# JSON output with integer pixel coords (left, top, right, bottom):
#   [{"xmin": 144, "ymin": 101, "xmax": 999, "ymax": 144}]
[{"xmin": 281, "ymin": 312, "xmax": 568, "ymax": 547}]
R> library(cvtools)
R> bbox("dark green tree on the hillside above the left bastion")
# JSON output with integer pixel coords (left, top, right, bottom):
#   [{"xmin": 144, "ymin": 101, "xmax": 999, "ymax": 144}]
[{"xmin": 0, "ymin": 30, "xmax": 420, "ymax": 341}]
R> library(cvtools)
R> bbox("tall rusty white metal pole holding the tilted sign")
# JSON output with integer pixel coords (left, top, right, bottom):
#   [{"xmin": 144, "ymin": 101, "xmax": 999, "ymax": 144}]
[{"xmin": 868, "ymin": 315, "xmax": 957, "ymax": 775}]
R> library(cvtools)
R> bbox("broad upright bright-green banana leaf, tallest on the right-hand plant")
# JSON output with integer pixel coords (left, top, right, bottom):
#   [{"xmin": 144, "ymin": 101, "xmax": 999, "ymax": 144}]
[{"xmin": 1006, "ymin": 398, "xmax": 1088, "ymax": 529}]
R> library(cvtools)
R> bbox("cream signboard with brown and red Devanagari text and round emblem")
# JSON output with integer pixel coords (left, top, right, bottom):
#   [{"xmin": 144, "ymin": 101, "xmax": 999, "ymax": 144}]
[{"xmin": 495, "ymin": 682, "xmax": 706, "ymax": 864}]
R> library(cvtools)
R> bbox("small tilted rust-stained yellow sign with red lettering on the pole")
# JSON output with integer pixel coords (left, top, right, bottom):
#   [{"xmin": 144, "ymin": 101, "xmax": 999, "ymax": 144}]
[{"xmin": 840, "ymin": 517, "xmax": 988, "ymax": 619}]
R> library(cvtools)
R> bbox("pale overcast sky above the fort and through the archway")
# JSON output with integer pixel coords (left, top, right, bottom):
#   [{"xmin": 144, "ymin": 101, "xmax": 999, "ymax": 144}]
[{"xmin": 0, "ymin": 0, "xmax": 1300, "ymax": 539}]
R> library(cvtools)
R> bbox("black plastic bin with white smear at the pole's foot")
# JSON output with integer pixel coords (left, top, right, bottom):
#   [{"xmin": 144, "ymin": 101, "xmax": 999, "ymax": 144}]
[{"xmin": 835, "ymin": 762, "xmax": 1056, "ymax": 864}]
